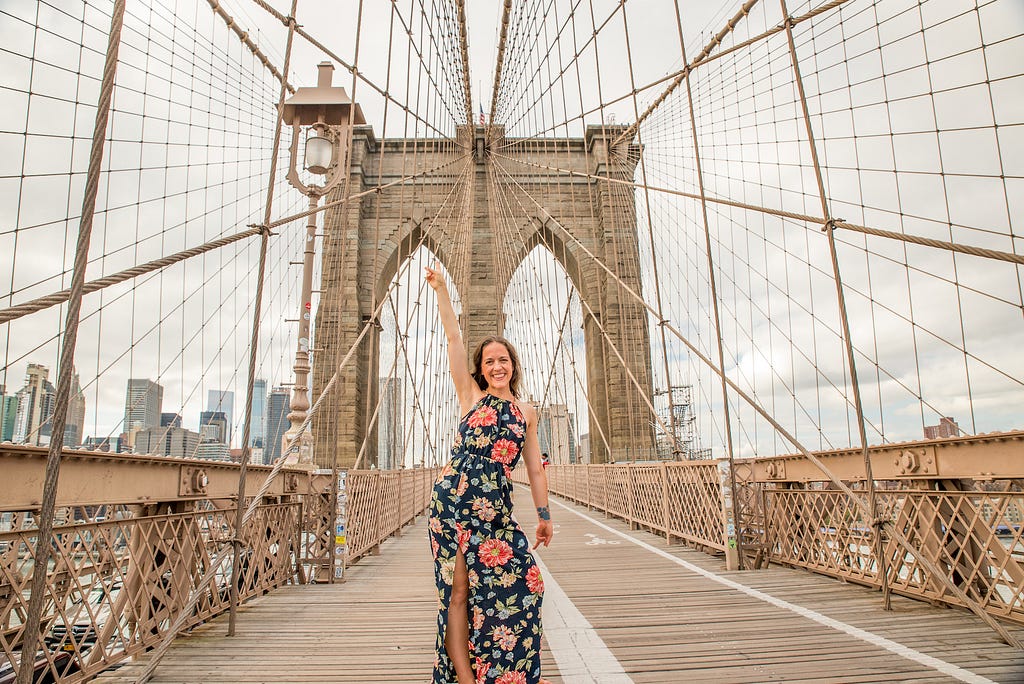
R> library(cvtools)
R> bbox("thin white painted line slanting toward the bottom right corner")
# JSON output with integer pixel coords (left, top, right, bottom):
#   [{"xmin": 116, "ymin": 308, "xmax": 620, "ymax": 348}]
[{"xmin": 545, "ymin": 499, "xmax": 996, "ymax": 684}]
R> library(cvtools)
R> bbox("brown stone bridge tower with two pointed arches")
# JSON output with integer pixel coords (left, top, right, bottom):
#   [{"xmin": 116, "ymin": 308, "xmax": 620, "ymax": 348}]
[{"xmin": 311, "ymin": 126, "xmax": 654, "ymax": 467}]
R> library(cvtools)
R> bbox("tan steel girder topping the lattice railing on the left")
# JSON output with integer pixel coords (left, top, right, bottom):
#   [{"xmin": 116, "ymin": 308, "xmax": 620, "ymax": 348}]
[{"xmin": 0, "ymin": 444, "xmax": 330, "ymax": 511}]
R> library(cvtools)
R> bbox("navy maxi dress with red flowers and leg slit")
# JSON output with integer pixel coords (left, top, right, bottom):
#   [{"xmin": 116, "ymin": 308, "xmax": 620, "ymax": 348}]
[{"xmin": 429, "ymin": 394, "xmax": 544, "ymax": 684}]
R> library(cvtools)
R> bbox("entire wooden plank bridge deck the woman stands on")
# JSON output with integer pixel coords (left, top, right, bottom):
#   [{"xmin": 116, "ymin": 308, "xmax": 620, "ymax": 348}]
[{"xmin": 97, "ymin": 489, "xmax": 1024, "ymax": 684}]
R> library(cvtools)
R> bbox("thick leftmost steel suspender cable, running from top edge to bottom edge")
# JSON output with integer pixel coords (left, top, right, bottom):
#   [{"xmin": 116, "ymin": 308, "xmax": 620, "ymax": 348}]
[{"xmin": 17, "ymin": 0, "xmax": 125, "ymax": 684}]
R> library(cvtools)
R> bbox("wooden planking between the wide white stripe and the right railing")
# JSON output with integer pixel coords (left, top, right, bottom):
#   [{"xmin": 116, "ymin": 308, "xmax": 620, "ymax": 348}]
[{"xmin": 536, "ymin": 491, "xmax": 1024, "ymax": 682}]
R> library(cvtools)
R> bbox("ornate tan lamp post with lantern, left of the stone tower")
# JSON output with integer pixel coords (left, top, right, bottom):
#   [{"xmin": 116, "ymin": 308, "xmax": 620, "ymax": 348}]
[{"xmin": 282, "ymin": 61, "xmax": 367, "ymax": 466}]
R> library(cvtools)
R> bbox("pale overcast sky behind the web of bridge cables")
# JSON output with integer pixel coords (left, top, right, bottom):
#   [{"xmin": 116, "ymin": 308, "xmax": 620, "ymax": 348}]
[{"xmin": 0, "ymin": 0, "xmax": 1024, "ymax": 453}]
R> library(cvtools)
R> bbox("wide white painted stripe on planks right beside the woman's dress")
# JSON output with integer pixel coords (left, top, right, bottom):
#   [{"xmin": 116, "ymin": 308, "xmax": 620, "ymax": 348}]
[{"xmin": 534, "ymin": 552, "xmax": 633, "ymax": 684}]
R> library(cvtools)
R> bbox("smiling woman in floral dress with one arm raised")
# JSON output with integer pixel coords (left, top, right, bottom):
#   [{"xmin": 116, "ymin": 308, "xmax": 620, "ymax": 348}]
[{"xmin": 426, "ymin": 264, "xmax": 552, "ymax": 684}]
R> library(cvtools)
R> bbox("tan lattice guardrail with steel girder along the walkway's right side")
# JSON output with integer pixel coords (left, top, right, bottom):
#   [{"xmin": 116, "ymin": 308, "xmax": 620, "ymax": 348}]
[{"xmin": 514, "ymin": 432, "xmax": 1024, "ymax": 625}]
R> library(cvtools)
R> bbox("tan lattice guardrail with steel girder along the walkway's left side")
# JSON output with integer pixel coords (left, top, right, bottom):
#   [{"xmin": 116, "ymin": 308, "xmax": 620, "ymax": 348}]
[{"xmin": 0, "ymin": 444, "xmax": 435, "ymax": 683}]
